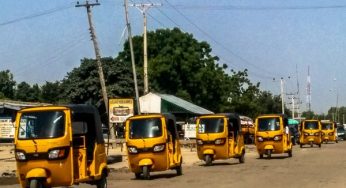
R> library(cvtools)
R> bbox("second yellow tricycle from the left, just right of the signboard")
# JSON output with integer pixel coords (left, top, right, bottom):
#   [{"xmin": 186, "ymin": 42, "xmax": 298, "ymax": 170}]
[{"xmin": 125, "ymin": 114, "xmax": 183, "ymax": 179}]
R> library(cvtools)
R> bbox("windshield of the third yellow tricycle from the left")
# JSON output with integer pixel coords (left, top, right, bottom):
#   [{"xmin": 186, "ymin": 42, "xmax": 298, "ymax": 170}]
[{"xmin": 198, "ymin": 118, "xmax": 224, "ymax": 133}]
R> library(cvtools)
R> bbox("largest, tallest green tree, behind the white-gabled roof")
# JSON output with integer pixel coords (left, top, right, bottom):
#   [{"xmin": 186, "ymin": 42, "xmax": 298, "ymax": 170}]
[{"xmin": 117, "ymin": 28, "xmax": 252, "ymax": 112}]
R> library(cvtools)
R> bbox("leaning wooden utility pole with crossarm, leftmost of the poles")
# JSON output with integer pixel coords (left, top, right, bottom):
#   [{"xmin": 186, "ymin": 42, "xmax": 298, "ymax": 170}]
[{"xmin": 76, "ymin": 1, "xmax": 114, "ymax": 135}]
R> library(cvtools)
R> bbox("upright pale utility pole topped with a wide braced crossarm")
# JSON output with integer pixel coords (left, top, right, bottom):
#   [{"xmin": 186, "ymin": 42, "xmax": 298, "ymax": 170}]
[{"xmin": 130, "ymin": 3, "xmax": 161, "ymax": 94}]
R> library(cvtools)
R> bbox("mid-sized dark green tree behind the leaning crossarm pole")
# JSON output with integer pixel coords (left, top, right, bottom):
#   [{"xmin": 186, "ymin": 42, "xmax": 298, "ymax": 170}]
[{"xmin": 61, "ymin": 57, "xmax": 134, "ymax": 104}]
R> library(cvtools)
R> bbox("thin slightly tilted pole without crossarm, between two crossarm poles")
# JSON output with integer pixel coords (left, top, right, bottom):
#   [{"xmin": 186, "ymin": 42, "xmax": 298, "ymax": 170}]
[{"xmin": 124, "ymin": 0, "xmax": 141, "ymax": 114}]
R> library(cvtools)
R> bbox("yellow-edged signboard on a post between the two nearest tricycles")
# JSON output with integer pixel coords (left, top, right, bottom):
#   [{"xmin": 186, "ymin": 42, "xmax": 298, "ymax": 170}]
[{"xmin": 108, "ymin": 99, "xmax": 134, "ymax": 123}]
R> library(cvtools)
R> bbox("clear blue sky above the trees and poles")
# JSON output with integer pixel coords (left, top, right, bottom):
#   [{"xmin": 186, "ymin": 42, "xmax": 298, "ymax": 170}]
[{"xmin": 0, "ymin": 0, "xmax": 346, "ymax": 113}]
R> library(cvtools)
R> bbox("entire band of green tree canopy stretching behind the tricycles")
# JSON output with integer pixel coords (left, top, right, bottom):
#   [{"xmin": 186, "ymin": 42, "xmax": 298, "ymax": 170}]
[{"xmin": 0, "ymin": 28, "xmax": 290, "ymax": 117}]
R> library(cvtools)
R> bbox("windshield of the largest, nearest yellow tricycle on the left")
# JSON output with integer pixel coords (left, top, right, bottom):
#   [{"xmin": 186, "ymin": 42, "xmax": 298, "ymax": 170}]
[{"xmin": 18, "ymin": 111, "xmax": 65, "ymax": 139}]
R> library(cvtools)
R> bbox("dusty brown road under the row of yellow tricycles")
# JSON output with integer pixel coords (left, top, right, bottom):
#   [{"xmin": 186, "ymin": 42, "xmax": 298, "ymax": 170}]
[{"xmin": 5, "ymin": 142, "xmax": 346, "ymax": 188}]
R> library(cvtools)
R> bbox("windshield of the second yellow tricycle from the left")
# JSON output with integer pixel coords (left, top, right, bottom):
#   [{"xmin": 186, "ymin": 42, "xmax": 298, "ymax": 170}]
[{"xmin": 129, "ymin": 118, "xmax": 162, "ymax": 139}]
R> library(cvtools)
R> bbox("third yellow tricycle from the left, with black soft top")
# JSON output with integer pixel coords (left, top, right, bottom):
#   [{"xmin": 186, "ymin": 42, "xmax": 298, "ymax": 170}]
[{"xmin": 196, "ymin": 113, "xmax": 245, "ymax": 166}]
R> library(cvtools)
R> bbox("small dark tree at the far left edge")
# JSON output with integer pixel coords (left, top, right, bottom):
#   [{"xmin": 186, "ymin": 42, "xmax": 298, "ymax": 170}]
[{"xmin": 0, "ymin": 70, "xmax": 16, "ymax": 99}]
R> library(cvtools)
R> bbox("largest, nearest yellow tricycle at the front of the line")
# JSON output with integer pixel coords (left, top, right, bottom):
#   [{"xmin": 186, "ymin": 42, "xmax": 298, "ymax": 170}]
[{"xmin": 14, "ymin": 105, "xmax": 108, "ymax": 188}]
